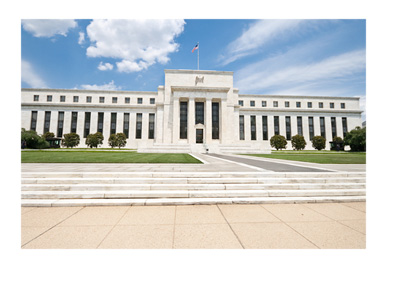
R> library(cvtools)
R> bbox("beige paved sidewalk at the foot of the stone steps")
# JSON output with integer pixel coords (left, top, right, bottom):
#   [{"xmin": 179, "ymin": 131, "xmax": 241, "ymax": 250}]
[{"xmin": 21, "ymin": 203, "xmax": 366, "ymax": 249}]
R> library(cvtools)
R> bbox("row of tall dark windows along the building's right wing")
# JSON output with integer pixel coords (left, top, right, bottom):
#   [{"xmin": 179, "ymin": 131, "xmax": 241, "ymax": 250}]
[{"xmin": 239, "ymin": 115, "xmax": 348, "ymax": 140}]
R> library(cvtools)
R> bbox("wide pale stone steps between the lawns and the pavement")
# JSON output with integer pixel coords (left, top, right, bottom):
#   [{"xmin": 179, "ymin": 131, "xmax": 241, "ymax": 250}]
[{"xmin": 21, "ymin": 172, "xmax": 366, "ymax": 207}]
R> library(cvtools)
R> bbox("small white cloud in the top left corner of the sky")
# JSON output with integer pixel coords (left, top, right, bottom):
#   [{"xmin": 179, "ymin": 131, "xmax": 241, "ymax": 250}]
[{"xmin": 21, "ymin": 20, "xmax": 78, "ymax": 38}]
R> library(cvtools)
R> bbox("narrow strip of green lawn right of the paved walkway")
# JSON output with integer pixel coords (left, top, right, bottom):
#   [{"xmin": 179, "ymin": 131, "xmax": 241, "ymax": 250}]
[{"xmin": 246, "ymin": 151, "xmax": 366, "ymax": 164}]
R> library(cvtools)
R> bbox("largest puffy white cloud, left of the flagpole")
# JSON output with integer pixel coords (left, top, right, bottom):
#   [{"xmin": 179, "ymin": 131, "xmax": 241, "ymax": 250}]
[{"xmin": 86, "ymin": 20, "xmax": 185, "ymax": 72}]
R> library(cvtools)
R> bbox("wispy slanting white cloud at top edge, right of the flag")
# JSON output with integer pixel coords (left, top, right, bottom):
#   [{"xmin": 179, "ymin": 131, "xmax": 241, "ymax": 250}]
[{"xmin": 220, "ymin": 20, "xmax": 310, "ymax": 65}]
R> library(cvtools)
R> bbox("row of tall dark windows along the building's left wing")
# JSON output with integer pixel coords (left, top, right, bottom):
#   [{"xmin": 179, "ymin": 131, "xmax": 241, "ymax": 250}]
[{"xmin": 30, "ymin": 111, "xmax": 155, "ymax": 139}]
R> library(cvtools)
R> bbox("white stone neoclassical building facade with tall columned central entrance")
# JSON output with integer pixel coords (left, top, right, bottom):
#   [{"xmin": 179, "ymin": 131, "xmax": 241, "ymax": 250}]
[{"xmin": 21, "ymin": 70, "xmax": 362, "ymax": 153}]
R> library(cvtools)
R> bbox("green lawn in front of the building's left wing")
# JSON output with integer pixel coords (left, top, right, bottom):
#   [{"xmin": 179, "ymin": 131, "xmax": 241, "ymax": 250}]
[{"xmin": 21, "ymin": 149, "xmax": 201, "ymax": 164}]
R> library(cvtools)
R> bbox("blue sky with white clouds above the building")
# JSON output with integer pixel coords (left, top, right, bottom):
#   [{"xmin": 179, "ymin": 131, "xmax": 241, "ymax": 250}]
[{"xmin": 21, "ymin": 19, "xmax": 366, "ymax": 116}]
